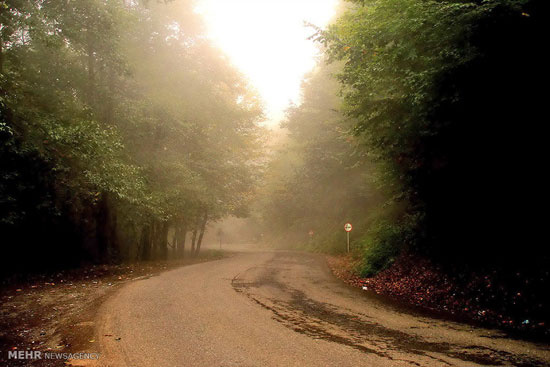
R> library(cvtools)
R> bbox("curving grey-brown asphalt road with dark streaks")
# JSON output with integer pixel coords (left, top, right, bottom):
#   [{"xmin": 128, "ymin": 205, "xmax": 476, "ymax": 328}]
[{"xmin": 97, "ymin": 247, "xmax": 550, "ymax": 367}]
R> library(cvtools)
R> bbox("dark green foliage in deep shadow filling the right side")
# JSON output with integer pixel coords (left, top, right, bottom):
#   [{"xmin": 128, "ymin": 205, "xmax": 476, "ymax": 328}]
[{"xmin": 318, "ymin": 0, "xmax": 548, "ymax": 270}]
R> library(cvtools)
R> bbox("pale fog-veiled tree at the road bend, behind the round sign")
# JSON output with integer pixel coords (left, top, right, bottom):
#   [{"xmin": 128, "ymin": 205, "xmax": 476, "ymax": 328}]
[{"xmin": 258, "ymin": 64, "xmax": 382, "ymax": 251}]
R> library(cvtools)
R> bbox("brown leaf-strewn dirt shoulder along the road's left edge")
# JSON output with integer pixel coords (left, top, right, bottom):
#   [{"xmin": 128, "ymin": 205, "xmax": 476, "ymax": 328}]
[{"xmin": 0, "ymin": 250, "xmax": 232, "ymax": 367}]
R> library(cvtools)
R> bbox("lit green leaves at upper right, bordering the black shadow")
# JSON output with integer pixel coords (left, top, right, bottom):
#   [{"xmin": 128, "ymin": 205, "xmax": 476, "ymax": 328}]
[{"xmin": 316, "ymin": 0, "xmax": 490, "ymax": 204}]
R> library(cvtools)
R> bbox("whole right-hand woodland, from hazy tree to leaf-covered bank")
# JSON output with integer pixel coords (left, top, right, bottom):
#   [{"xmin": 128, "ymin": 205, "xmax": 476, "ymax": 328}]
[{"xmin": 256, "ymin": 0, "xmax": 550, "ymax": 335}]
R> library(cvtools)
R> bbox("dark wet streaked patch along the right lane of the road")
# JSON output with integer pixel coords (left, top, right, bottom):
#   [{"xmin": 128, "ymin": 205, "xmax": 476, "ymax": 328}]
[{"xmin": 231, "ymin": 253, "xmax": 546, "ymax": 367}]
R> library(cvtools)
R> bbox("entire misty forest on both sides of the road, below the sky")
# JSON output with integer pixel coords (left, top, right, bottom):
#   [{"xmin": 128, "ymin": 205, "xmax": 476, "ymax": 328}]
[{"xmin": 0, "ymin": 0, "xmax": 550, "ymax": 330}]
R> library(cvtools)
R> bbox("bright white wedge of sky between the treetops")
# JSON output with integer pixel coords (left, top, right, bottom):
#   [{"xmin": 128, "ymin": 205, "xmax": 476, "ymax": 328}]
[{"xmin": 196, "ymin": 0, "xmax": 338, "ymax": 125}]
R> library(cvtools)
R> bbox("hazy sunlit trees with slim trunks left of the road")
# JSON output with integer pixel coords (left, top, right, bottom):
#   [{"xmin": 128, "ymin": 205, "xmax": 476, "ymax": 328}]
[{"xmin": 0, "ymin": 0, "xmax": 261, "ymax": 269}]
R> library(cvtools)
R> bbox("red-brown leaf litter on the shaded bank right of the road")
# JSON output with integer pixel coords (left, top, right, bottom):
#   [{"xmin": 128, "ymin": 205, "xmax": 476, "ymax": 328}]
[{"xmin": 327, "ymin": 254, "xmax": 550, "ymax": 339}]
